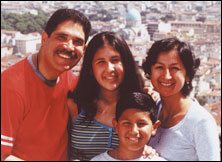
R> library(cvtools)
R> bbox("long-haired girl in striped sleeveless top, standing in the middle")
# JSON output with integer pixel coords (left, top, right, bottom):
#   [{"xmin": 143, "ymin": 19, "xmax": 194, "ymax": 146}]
[{"xmin": 69, "ymin": 32, "xmax": 144, "ymax": 160}]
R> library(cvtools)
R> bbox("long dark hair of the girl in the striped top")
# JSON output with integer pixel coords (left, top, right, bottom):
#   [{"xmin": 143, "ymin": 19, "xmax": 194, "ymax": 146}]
[{"xmin": 69, "ymin": 32, "xmax": 144, "ymax": 120}]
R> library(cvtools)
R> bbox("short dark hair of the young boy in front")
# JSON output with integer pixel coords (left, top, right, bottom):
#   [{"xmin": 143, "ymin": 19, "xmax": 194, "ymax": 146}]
[{"xmin": 116, "ymin": 92, "xmax": 157, "ymax": 123}]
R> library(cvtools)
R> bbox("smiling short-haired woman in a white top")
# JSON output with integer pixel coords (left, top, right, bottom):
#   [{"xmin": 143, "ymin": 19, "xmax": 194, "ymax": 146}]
[{"xmin": 143, "ymin": 38, "xmax": 220, "ymax": 161}]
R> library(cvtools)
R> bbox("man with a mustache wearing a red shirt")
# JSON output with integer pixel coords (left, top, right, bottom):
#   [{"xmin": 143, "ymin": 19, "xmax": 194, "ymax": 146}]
[{"xmin": 1, "ymin": 9, "xmax": 91, "ymax": 161}]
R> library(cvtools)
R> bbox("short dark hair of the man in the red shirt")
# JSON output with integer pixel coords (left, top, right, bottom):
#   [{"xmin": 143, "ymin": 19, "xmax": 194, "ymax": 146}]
[{"xmin": 45, "ymin": 9, "xmax": 91, "ymax": 42}]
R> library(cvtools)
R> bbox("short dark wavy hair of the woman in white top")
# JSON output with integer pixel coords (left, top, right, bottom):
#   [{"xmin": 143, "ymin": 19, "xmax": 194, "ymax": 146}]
[{"xmin": 142, "ymin": 38, "xmax": 200, "ymax": 96}]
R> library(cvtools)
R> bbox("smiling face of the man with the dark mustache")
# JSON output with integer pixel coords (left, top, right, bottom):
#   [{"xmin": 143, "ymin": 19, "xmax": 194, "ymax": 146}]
[{"xmin": 40, "ymin": 20, "xmax": 85, "ymax": 79}]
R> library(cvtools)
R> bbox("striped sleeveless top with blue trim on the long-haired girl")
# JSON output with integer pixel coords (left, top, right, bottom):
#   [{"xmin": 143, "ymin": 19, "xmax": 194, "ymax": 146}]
[{"xmin": 71, "ymin": 111, "xmax": 119, "ymax": 161}]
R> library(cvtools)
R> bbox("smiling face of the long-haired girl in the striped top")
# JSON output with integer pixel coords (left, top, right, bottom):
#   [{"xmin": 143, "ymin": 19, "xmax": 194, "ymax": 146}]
[{"xmin": 92, "ymin": 45, "xmax": 124, "ymax": 91}]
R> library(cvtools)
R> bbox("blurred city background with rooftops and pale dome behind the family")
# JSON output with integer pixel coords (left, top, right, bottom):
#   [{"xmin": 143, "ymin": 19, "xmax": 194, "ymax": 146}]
[{"xmin": 1, "ymin": 1, "xmax": 221, "ymax": 137}]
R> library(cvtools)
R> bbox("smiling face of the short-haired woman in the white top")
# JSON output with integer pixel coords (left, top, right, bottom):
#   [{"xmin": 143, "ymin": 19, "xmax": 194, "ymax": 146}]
[{"xmin": 151, "ymin": 50, "xmax": 189, "ymax": 97}]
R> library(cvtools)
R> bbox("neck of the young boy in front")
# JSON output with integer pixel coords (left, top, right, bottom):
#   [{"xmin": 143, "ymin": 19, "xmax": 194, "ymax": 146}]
[{"xmin": 110, "ymin": 146, "xmax": 144, "ymax": 160}]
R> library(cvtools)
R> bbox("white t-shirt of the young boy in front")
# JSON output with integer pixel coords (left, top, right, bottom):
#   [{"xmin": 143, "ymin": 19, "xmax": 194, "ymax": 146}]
[{"xmin": 90, "ymin": 151, "xmax": 167, "ymax": 161}]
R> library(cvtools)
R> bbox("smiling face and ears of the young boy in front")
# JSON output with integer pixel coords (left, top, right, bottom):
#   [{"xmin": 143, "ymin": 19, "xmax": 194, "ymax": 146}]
[{"xmin": 113, "ymin": 108, "xmax": 160, "ymax": 152}]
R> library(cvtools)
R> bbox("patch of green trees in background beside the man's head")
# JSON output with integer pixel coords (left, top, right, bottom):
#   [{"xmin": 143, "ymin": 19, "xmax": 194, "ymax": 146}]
[{"xmin": 1, "ymin": 10, "xmax": 48, "ymax": 34}]
